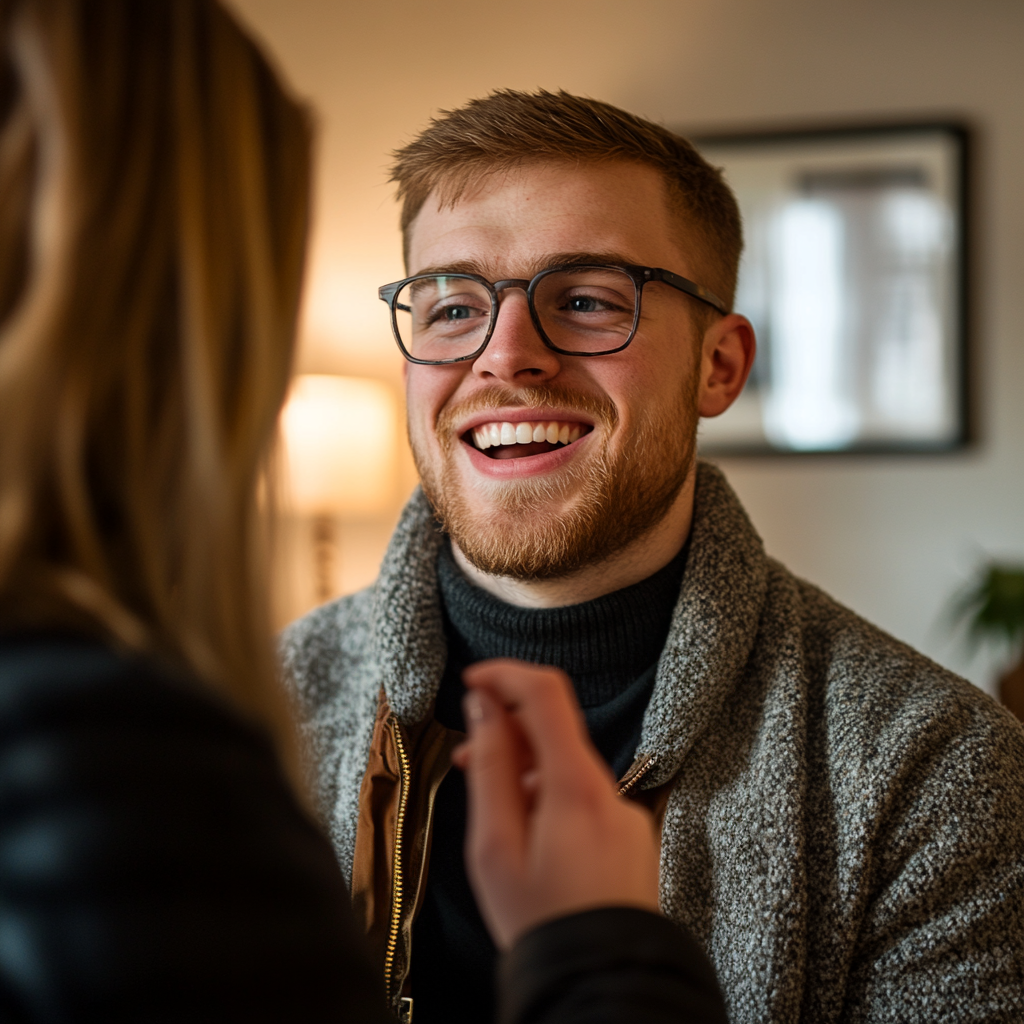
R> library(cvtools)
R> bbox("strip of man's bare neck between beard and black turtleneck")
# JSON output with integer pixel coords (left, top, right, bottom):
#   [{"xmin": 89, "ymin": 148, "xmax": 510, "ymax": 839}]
[{"xmin": 452, "ymin": 471, "xmax": 696, "ymax": 608}]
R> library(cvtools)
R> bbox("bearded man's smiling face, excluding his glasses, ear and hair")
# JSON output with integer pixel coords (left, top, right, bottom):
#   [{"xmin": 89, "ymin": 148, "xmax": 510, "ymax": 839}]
[{"xmin": 407, "ymin": 163, "xmax": 700, "ymax": 579}]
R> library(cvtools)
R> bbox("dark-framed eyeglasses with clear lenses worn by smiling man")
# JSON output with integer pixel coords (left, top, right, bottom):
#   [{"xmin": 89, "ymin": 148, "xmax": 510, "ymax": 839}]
[{"xmin": 378, "ymin": 264, "xmax": 729, "ymax": 365}]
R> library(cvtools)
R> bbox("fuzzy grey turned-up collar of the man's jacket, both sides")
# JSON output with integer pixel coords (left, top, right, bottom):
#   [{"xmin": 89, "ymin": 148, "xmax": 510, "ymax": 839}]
[{"xmin": 373, "ymin": 462, "xmax": 768, "ymax": 788}]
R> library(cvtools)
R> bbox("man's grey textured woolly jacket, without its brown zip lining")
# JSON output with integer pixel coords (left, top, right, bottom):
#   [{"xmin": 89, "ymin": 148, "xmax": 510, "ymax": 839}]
[{"xmin": 284, "ymin": 464, "xmax": 1024, "ymax": 1024}]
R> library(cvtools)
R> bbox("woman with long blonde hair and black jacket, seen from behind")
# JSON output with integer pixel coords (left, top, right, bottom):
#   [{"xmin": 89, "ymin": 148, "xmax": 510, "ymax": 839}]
[{"xmin": 0, "ymin": 0, "xmax": 714, "ymax": 1024}]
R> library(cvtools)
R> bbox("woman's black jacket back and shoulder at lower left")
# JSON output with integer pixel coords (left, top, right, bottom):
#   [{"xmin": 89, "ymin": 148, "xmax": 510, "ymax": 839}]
[{"xmin": 0, "ymin": 635, "xmax": 387, "ymax": 1022}]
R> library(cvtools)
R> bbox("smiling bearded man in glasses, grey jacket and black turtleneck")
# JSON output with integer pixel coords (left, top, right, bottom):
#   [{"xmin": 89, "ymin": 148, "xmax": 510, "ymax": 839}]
[{"xmin": 285, "ymin": 92, "xmax": 1024, "ymax": 1024}]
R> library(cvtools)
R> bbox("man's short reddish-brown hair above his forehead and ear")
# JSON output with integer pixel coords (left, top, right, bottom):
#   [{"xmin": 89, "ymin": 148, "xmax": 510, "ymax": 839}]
[{"xmin": 391, "ymin": 89, "xmax": 743, "ymax": 307}]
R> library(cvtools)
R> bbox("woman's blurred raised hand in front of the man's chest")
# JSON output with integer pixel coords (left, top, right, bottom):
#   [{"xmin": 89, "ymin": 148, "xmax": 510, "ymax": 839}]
[{"xmin": 453, "ymin": 660, "xmax": 658, "ymax": 948}]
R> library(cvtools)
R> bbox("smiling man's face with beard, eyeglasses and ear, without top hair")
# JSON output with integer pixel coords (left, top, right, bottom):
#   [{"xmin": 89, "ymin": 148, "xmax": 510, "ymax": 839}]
[{"xmin": 391, "ymin": 154, "xmax": 754, "ymax": 606}]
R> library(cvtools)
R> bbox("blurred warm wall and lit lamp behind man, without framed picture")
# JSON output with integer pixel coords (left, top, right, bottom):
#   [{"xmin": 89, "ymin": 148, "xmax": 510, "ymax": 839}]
[{"xmin": 231, "ymin": 0, "xmax": 1024, "ymax": 690}]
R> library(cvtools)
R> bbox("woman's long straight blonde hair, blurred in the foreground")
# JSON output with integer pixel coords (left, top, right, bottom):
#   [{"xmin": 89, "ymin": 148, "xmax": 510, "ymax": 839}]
[{"xmin": 0, "ymin": 0, "xmax": 310, "ymax": 770}]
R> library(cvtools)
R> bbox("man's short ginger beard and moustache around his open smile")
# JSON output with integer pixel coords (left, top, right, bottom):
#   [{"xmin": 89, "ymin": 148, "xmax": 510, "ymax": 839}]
[{"xmin": 411, "ymin": 375, "xmax": 697, "ymax": 580}]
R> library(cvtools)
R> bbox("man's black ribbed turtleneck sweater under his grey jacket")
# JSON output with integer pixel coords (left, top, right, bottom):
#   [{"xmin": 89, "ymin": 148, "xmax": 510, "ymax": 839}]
[{"xmin": 412, "ymin": 544, "xmax": 686, "ymax": 1024}]
